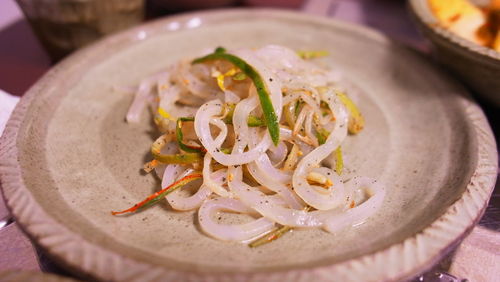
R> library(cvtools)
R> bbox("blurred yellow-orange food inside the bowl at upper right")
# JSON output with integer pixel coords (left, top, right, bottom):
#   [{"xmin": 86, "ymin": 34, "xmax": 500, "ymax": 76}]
[{"xmin": 428, "ymin": 0, "xmax": 500, "ymax": 51}]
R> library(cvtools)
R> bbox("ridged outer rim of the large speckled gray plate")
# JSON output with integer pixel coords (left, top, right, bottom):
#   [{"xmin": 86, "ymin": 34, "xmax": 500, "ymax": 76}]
[{"xmin": 0, "ymin": 9, "xmax": 498, "ymax": 281}]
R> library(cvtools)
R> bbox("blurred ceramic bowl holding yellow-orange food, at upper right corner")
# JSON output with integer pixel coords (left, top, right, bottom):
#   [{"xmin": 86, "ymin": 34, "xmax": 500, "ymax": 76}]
[{"xmin": 409, "ymin": 0, "xmax": 500, "ymax": 107}]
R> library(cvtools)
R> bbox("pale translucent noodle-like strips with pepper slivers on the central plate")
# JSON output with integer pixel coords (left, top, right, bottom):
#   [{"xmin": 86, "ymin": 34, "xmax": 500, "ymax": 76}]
[{"xmin": 112, "ymin": 45, "xmax": 385, "ymax": 247}]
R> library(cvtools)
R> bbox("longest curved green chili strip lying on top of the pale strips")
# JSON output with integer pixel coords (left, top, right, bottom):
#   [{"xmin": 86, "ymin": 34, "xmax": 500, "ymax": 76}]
[{"xmin": 192, "ymin": 48, "xmax": 280, "ymax": 145}]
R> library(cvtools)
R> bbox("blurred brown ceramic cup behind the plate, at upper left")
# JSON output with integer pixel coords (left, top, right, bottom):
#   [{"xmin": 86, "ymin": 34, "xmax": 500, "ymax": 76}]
[{"xmin": 16, "ymin": 0, "xmax": 145, "ymax": 62}]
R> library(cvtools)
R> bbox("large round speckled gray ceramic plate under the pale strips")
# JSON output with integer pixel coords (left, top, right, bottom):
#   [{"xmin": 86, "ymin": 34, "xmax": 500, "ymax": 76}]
[{"xmin": 0, "ymin": 10, "xmax": 497, "ymax": 281}]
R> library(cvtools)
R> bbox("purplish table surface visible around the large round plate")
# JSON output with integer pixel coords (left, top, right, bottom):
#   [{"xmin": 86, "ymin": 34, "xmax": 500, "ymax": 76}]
[{"xmin": 0, "ymin": 0, "xmax": 500, "ymax": 281}]
